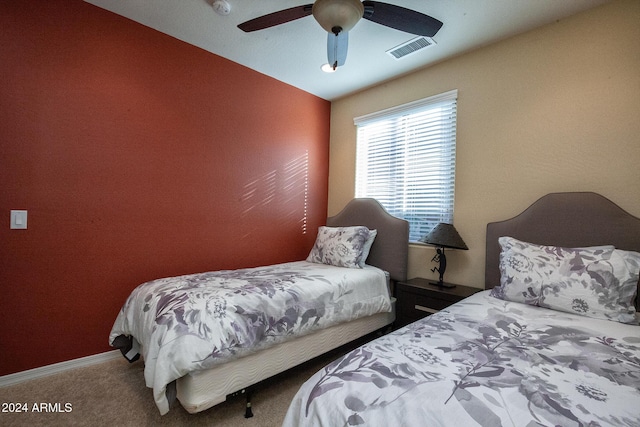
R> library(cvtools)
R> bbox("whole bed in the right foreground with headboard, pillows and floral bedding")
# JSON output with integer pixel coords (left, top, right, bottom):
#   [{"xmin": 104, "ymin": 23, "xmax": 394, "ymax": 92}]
[{"xmin": 283, "ymin": 192, "xmax": 640, "ymax": 427}]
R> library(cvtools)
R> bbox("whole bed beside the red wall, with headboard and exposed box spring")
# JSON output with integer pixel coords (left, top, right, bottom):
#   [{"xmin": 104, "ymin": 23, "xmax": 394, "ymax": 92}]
[{"xmin": 109, "ymin": 199, "xmax": 409, "ymax": 416}]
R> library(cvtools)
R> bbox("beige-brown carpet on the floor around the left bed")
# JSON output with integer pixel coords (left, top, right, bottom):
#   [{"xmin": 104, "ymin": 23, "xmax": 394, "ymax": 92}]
[{"xmin": 0, "ymin": 342, "xmax": 362, "ymax": 427}]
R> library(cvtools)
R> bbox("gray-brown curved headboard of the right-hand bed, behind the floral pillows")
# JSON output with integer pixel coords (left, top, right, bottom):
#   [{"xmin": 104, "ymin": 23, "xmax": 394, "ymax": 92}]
[{"xmin": 485, "ymin": 192, "xmax": 640, "ymax": 304}]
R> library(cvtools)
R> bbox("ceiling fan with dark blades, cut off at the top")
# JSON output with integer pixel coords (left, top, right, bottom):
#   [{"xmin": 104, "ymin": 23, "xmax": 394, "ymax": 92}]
[{"xmin": 238, "ymin": 0, "xmax": 442, "ymax": 70}]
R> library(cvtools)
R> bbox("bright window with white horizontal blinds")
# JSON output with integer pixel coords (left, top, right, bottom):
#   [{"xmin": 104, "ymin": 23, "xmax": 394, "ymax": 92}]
[{"xmin": 354, "ymin": 90, "xmax": 458, "ymax": 242}]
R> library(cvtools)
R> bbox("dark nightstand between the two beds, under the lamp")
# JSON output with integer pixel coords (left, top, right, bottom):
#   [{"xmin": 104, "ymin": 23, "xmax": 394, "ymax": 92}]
[{"xmin": 394, "ymin": 277, "xmax": 482, "ymax": 328}]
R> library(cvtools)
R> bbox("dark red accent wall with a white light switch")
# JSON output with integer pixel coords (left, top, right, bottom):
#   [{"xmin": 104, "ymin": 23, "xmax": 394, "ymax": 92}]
[{"xmin": 0, "ymin": 0, "xmax": 331, "ymax": 375}]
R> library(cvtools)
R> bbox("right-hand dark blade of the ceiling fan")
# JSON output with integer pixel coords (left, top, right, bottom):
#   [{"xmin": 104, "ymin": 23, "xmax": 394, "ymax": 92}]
[{"xmin": 362, "ymin": 0, "xmax": 442, "ymax": 37}]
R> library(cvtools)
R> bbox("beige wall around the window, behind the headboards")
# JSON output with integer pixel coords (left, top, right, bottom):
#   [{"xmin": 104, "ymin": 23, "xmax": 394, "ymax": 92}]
[{"xmin": 328, "ymin": 0, "xmax": 640, "ymax": 287}]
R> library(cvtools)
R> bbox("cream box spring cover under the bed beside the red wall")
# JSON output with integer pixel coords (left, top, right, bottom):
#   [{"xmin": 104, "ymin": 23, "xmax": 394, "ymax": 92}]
[{"xmin": 176, "ymin": 298, "xmax": 395, "ymax": 414}]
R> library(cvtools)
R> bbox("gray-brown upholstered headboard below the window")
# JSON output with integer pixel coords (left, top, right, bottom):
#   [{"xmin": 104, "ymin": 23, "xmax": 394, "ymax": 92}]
[{"xmin": 327, "ymin": 199, "xmax": 409, "ymax": 281}]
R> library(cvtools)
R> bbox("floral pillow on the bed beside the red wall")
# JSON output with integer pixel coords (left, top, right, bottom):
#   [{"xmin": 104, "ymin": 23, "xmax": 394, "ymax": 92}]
[{"xmin": 307, "ymin": 226, "xmax": 377, "ymax": 268}]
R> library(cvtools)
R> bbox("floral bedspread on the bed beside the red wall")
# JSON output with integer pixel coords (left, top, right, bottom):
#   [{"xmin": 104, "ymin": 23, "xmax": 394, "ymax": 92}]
[{"xmin": 109, "ymin": 261, "xmax": 391, "ymax": 414}]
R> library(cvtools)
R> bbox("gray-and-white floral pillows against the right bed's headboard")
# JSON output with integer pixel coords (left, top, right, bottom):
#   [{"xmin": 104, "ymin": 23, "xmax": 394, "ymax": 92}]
[{"xmin": 492, "ymin": 237, "xmax": 640, "ymax": 323}]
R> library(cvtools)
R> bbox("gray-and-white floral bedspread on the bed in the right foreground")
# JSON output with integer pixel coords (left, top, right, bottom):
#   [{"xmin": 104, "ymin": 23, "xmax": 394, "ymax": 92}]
[{"xmin": 284, "ymin": 291, "xmax": 640, "ymax": 427}]
